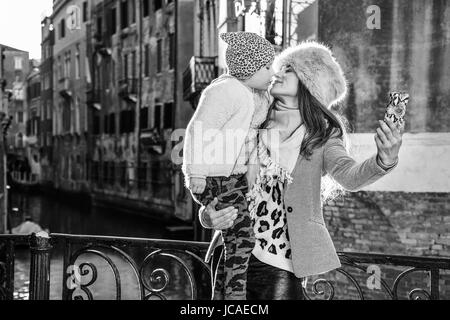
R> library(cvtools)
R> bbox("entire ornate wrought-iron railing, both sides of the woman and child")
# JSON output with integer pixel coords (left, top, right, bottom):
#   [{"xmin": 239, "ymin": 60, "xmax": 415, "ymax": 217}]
[{"xmin": 0, "ymin": 234, "xmax": 450, "ymax": 300}]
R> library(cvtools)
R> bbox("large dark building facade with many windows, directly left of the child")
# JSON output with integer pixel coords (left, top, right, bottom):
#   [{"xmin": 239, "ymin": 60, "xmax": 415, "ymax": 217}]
[{"xmin": 82, "ymin": 0, "xmax": 194, "ymax": 220}]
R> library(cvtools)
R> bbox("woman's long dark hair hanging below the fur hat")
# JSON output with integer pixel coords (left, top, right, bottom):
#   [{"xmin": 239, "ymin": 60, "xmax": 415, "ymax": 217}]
[{"xmin": 261, "ymin": 80, "xmax": 350, "ymax": 202}]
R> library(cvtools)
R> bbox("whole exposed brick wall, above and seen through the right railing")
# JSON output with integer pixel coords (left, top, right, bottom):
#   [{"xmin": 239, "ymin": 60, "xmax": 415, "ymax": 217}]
[{"xmin": 300, "ymin": 191, "xmax": 450, "ymax": 300}]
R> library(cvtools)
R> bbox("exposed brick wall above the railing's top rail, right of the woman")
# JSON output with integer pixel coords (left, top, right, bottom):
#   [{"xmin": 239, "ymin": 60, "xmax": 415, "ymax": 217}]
[{"xmin": 324, "ymin": 191, "xmax": 450, "ymax": 256}]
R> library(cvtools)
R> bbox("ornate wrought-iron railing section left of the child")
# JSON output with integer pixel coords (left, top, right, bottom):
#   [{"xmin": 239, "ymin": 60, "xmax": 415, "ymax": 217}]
[{"xmin": 0, "ymin": 234, "xmax": 217, "ymax": 300}]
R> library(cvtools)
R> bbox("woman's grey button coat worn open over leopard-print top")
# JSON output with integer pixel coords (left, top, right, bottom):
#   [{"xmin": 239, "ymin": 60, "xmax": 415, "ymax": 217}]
[{"xmin": 203, "ymin": 129, "xmax": 398, "ymax": 278}]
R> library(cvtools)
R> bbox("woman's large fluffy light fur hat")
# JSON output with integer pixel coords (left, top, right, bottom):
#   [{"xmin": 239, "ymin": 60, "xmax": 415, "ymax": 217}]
[{"xmin": 275, "ymin": 41, "xmax": 347, "ymax": 108}]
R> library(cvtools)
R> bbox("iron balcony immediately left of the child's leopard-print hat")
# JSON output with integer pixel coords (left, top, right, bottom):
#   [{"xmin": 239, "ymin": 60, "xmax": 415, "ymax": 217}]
[{"xmin": 183, "ymin": 57, "xmax": 218, "ymax": 101}]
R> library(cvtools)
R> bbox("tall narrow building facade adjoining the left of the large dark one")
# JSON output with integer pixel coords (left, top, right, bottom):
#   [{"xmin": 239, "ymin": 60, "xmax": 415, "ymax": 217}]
[{"xmin": 52, "ymin": 0, "xmax": 89, "ymax": 192}]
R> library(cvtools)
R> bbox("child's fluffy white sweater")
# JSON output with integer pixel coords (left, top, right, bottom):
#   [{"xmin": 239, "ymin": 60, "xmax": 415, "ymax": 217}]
[{"xmin": 182, "ymin": 75, "xmax": 255, "ymax": 184}]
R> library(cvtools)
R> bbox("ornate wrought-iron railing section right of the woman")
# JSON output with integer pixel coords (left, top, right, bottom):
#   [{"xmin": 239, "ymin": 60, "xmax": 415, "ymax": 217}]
[{"xmin": 303, "ymin": 252, "xmax": 450, "ymax": 300}]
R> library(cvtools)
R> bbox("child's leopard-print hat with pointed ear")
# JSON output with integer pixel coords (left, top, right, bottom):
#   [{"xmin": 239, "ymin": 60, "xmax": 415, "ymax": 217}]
[{"xmin": 220, "ymin": 31, "xmax": 275, "ymax": 80}]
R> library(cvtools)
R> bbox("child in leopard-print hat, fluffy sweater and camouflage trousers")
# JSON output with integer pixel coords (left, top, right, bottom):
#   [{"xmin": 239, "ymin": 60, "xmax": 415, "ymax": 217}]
[{"xmin": 183, "ymin": 32, "xmax": 275, "ymax": 300}]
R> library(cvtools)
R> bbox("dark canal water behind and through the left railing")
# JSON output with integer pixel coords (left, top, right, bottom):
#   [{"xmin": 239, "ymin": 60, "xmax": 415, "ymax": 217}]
[{"xmin": 10, "ymin": 191, "xmax": 199, "ymax": 300}]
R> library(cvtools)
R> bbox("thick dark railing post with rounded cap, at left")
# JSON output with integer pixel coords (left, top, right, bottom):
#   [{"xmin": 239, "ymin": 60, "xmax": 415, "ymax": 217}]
[{"xmin": 30, "ymin": 232, "xmax": 53, "ymax": 300}]
